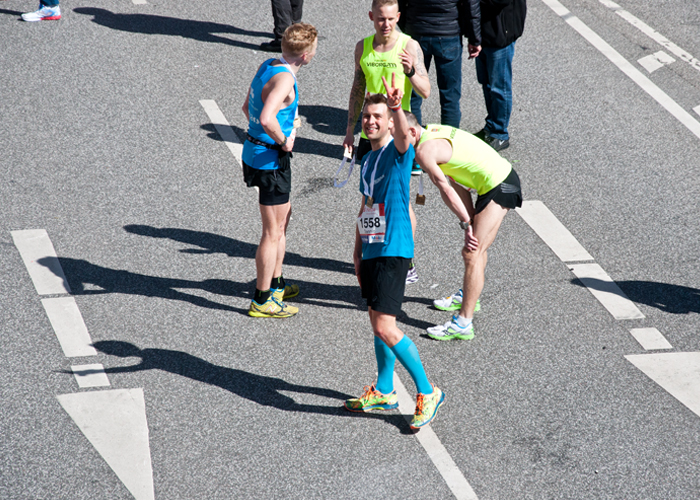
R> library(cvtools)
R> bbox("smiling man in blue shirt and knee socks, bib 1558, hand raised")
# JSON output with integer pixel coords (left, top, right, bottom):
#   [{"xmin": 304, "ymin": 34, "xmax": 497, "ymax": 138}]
[{"xmin": 345, "ymin": 75, "xmax": 445, "ymax": 429}]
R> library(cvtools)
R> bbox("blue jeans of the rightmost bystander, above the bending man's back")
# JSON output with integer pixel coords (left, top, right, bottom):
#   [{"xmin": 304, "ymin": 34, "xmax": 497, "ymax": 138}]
[{"xmin": 476, "ymin": 42, "xmax": 515, "ymax": 141}]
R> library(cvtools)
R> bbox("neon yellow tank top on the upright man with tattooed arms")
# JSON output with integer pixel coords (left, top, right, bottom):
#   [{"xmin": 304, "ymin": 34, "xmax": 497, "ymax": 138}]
[{"xmin": 360, "ymin": 33, "xmax": 413, "ymax": 138}]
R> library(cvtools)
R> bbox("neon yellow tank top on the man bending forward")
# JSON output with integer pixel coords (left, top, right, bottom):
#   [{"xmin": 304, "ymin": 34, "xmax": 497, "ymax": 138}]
[{"xmin": 418, "ymin": 125, "xmax": 512, "ymax": 195}]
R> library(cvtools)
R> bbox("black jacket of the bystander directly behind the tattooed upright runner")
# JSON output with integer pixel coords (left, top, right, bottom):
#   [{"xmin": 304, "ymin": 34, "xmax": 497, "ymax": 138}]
[{"xmin": 399, "ymin": 0, "xmax": 481, "ymax": 45}]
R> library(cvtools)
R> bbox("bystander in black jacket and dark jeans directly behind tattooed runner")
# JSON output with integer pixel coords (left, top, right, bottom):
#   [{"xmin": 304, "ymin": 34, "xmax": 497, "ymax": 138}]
[{"xmin": 399, "ymin": 0, "xmax": 481, "ymax": 128}]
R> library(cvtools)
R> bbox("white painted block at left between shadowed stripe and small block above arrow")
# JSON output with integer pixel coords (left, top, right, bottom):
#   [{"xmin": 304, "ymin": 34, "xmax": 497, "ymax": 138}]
[{"xmin": 41, "ymin": 297, "xmax": 97, "ymax": 358}]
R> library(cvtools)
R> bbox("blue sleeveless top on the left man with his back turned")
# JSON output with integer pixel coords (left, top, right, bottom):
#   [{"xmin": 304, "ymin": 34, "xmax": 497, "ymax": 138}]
[{"xmin": 242, "ymin": 59, "xmax": 299, "ymax": 170}]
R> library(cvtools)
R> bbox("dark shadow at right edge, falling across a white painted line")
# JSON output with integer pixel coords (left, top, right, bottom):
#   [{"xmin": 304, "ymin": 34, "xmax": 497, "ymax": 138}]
[{"xmin": 571, "ymin": 279, "xmax": 700, "ymax": 314}]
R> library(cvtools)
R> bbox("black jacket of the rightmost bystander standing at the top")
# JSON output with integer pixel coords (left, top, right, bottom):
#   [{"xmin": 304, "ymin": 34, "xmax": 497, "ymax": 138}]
[{"xmin": 481, "ymin": 0, "xmax": 527, "ymax": 49}]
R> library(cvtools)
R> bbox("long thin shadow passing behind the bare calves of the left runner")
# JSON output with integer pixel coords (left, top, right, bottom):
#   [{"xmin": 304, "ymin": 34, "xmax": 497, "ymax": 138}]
[{"xmin": 124, "ymin": 224, "xmax": 355, "ymax": 275}]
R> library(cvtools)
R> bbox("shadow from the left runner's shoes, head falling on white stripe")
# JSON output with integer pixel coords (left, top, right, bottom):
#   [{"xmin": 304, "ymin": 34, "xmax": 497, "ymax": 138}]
[{"xmin": 37, "ymin": 257, "xmax": 253, "ymax": 314}]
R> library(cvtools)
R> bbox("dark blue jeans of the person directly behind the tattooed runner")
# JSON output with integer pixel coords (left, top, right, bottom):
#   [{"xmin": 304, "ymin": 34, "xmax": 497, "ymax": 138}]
[{"xmin": 411, "ymin": 36, "xmax": 462, "ymax": 128}]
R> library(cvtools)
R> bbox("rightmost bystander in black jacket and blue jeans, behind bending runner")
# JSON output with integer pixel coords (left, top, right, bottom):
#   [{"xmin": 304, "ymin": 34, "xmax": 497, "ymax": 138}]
[{"xmin": 475, "ymin": 0, "xmax": 527, "ymax": 151}]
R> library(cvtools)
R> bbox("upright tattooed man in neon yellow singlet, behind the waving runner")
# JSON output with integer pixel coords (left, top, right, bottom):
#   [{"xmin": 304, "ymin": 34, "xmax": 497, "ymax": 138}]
[{"xmin": 343, "ymin": 0, "xmax": 430, "ymax": 283}]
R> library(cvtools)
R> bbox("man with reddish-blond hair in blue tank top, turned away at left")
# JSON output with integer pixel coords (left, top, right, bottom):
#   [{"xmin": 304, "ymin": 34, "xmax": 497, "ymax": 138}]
[{"xmin": 242, "ymin": 23, "xmax": 318, "ymax": 318}]
